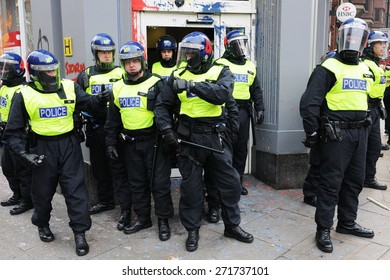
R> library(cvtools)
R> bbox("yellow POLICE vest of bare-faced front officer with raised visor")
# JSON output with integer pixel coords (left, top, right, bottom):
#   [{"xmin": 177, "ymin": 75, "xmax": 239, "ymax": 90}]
[{"xmin": 113, "ymin": 76, "xmax": 161, "ymax": 130}]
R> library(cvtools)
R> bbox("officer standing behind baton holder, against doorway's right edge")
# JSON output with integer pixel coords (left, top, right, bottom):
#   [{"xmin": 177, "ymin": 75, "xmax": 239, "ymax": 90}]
[{"xmin": 215, "ymin": 30, "xmax": 264, "ymax": 195}]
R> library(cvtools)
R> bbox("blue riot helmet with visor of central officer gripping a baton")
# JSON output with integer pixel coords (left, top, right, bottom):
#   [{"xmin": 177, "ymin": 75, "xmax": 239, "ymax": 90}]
[{"xmin": 177, "ymin": 32, "xmax": 213, "ymax": 73}]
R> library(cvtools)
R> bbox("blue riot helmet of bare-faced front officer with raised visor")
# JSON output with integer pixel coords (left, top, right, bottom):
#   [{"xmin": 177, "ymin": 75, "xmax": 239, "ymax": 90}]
[{"xmin": 119, "ymin": 41, "xmax": 148, "ymax": 80}]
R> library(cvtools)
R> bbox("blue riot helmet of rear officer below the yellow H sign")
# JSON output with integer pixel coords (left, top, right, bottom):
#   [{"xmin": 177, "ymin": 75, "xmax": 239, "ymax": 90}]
[{"xmin": 91, "ymin": 33, "xmax": 115, "ymax": 70}]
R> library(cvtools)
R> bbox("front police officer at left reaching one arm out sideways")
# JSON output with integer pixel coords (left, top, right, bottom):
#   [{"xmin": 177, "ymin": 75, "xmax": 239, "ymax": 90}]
[{"xmin": 3, "ymin": 50, "xmax": 109, "ymax": 256}]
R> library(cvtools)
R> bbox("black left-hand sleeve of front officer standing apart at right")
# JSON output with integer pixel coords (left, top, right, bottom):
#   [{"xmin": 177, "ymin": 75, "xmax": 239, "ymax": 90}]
[{"xmin": 299, "ymin": 65, "xmax": 336, "ymax": 135}]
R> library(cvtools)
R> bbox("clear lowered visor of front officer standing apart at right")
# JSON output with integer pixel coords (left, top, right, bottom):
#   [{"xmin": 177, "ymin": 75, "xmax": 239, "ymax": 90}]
[{"xmin": 338, "ymin": 27, "xmax": 368, "ymax": 53}]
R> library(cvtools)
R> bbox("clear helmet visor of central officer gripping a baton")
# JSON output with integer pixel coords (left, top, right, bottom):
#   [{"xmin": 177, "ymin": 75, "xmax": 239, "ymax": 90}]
[{"xmin": 176, "ymin": 43, "xmax": 204, "ymax": 70}]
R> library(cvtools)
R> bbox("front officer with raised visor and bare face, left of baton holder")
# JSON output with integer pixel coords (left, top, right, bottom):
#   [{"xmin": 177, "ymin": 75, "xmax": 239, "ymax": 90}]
[{"xmin": 105, "ymin": 41, "xmax": 174, "ymax": 241}]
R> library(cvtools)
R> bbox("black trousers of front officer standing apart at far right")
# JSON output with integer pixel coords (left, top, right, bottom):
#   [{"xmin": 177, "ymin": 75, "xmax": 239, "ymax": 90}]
[{"xmin": 315, "ymin": 127, "xmax": 368, "ymax": 229}]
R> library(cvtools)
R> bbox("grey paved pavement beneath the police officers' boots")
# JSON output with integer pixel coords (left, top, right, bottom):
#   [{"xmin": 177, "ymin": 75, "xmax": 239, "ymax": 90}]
[{"xmin": 0, "ymin": 135, "xmax": 390, "ymax": 264}]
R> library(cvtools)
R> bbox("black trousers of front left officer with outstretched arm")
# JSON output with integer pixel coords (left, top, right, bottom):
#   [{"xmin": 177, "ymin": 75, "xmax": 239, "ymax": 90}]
[{"xmin": 30, "ymin": 134, "xmax": 91, "ymax": 232}]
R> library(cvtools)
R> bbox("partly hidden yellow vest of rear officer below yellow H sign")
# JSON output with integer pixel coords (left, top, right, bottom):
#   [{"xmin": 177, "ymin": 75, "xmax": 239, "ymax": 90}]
[{"xmin": 85, "ymin": 67, "xmax": 122, "ymax": 94}]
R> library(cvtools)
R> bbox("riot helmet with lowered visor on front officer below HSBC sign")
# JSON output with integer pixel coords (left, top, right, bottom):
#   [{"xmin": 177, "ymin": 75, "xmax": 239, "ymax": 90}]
[{"xmin": 337, "ymin": 18, "xmax": 368, "ymax": 54}]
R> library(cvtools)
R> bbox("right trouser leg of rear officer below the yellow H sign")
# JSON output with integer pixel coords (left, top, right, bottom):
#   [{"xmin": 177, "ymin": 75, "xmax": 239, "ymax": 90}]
[{"xmin": 109, "ymin": 142, "xmax": 133, "ymax": 210}]
